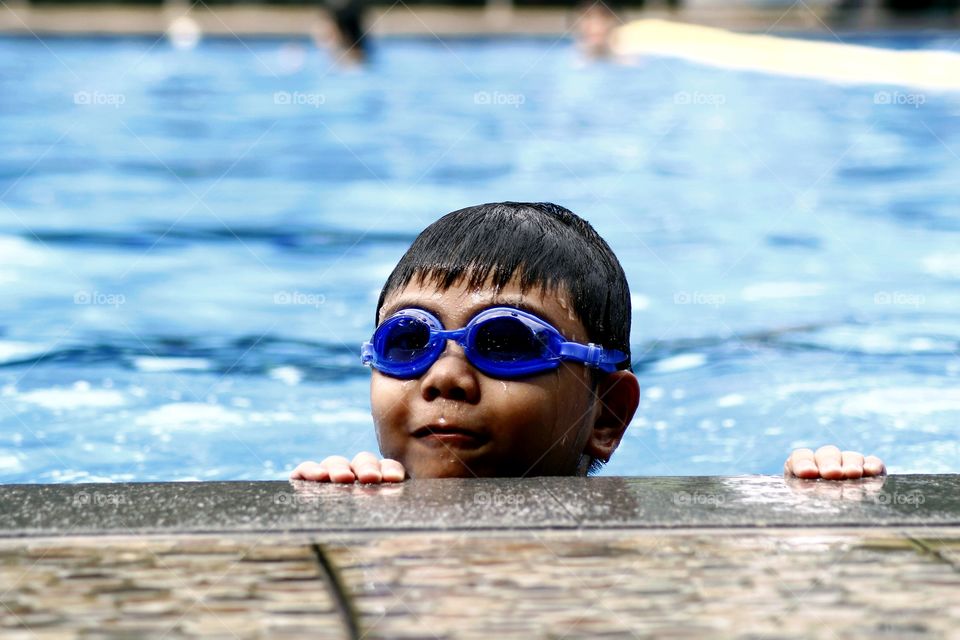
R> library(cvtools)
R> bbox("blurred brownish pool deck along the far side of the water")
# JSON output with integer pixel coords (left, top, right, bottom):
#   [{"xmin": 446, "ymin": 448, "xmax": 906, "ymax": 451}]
[{"xmin": 0, "ymin": 0, "xmax": 960, "ymax": 36}]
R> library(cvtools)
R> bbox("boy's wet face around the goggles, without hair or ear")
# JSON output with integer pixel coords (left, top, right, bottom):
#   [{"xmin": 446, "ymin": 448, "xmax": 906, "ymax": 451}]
[{"xmin": 370, "ymin": 282, "xmax": 599, "ymax": 478}]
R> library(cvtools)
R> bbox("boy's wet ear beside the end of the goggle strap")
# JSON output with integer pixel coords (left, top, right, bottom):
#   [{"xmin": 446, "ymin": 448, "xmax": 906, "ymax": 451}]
[{"xmin": 583, "ymin": 371, "xmax": 640, "ymax": 462}]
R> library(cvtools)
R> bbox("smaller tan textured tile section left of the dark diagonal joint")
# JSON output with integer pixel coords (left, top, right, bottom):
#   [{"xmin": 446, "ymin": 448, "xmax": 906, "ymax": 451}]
[{"xmin": 0, "ymin": 538, "xmax": 344, "ymax": 640}]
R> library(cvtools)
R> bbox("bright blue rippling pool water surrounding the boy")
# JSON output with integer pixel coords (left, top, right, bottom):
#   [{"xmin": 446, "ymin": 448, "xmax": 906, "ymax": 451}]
[{"xmin": 0, "ymin": 31, "xmax": 960, "ymax": 482}]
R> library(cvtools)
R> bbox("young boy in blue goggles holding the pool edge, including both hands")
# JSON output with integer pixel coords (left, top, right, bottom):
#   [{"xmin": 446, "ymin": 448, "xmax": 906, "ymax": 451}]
[{"xmin": 290, "ymin": 202, "xmax": 884, "ymax": 483}]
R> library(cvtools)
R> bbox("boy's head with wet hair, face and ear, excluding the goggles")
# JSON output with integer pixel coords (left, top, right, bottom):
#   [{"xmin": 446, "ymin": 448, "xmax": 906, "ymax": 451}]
[{"xmin": 371, "ymin": 202, "xmax": 639, "ymax": 477}]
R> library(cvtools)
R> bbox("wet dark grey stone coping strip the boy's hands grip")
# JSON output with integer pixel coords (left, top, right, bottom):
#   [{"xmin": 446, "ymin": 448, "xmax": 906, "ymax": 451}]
[{"xmin": 0, "ymin": 475, "xmax": 960, "ymax": 536}]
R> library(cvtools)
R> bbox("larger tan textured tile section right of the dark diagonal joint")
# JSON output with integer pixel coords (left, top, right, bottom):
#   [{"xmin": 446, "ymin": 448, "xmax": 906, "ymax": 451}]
[{"xmin": 328, "ymin": 530, "xmax": 960, "ymax": 639}]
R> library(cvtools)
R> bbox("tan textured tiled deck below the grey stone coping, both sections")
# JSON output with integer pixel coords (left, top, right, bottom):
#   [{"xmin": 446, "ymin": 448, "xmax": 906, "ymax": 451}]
[{"xmin": 0, "ymin": 527, "xmax": 960, "ymax": 640}]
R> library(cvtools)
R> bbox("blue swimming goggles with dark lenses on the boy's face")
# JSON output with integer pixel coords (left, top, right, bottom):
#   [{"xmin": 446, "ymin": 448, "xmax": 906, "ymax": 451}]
[{"xmin": 360, "ymin": 307, "xmax": 627, "ymax": 378}]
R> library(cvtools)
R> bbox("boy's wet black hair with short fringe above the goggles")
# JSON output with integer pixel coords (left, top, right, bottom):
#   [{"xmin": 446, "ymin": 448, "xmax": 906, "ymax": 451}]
[{"xmin": 375, "ymin": 202, "xmax": 630, "ymax": 370}]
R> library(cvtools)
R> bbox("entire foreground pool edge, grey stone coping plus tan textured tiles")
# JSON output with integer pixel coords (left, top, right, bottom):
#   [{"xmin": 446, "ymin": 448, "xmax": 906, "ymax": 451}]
[{"xmin": 0, "ymin": 475, "xmax": 960, "ymax": 639}]
